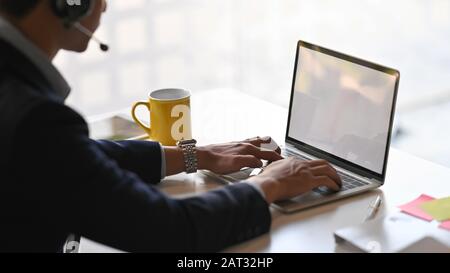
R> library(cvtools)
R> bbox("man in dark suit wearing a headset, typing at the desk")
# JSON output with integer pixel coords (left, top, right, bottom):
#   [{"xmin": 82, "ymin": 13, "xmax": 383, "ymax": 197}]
[{"xmin": 0, "ymin": 0, "xmax": 340, "ymax": 252}]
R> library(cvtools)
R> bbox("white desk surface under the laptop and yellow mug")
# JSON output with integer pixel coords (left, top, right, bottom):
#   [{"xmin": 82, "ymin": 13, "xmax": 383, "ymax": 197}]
[{"xmin": 80, "ymin": 90, "xmax": 450, "ymax": 252}]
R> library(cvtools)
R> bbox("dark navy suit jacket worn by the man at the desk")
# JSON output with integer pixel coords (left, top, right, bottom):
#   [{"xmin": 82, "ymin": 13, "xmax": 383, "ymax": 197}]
[{"xmin": 0, "ymin": 37, "xmax": 271, "ymax": 252}]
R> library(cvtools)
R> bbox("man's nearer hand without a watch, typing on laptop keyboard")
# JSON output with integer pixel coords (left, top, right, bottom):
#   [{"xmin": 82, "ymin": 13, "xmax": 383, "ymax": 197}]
[{"xmin": 248, "ymin": 158, "xmax": 342, "ymax": 204}]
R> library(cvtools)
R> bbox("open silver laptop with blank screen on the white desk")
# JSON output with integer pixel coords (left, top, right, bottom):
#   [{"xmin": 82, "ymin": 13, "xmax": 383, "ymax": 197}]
[{"xmin": 202, "ymin": 41, "xmax": 400, "ymax": 213}]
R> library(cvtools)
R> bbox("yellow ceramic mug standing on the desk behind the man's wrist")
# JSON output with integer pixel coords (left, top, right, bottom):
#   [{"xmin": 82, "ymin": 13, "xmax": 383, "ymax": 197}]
[{"xmin": 131, "ymin": 89, "xmax": 192, "ymax": 146}]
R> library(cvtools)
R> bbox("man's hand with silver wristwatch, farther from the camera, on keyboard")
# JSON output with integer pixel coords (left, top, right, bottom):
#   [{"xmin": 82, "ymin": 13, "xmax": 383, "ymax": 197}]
[{"xmin": 197, "ymin": 137, "xmax": 283, "ymax": 174}]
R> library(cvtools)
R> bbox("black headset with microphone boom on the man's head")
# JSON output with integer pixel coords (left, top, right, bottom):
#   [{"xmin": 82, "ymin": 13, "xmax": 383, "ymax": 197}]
[{"xmin": 50, "ymin": 0, "xmax": 109, "ymax": 51}]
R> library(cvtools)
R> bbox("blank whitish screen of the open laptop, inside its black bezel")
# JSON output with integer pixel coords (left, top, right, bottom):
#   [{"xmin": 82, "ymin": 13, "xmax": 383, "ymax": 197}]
[{"xmin": 288, "ymin": 46, "xmax": 396, "ymax": 174}]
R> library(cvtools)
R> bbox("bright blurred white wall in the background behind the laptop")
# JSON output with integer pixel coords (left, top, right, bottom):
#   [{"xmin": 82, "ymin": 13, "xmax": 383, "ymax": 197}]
[{"xmin": 56, "ymin": 0, "xmax": 450, "ymax": 165}]
